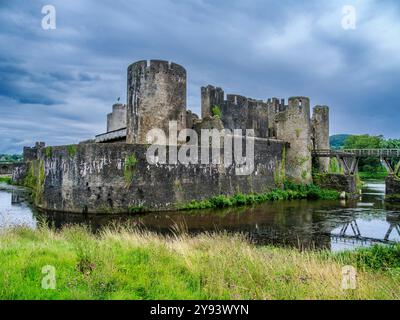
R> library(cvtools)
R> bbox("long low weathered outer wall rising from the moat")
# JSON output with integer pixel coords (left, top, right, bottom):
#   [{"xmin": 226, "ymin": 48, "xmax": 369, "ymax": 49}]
[{"xmin": 27, "ymin": 140, "xmax": 285, "ymax": 213}]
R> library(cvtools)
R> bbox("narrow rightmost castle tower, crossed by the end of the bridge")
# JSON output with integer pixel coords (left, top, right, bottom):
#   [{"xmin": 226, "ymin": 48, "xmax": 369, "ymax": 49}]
[{"xmin": 311, "ymin": 106, "xmax": 330, "ymax": 173}]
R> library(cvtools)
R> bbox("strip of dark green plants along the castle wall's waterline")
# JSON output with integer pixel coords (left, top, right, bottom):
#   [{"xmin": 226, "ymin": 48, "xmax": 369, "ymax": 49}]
[{"xmin": 179, "ymin": 182, "xmax": 339, "ymax": 210}]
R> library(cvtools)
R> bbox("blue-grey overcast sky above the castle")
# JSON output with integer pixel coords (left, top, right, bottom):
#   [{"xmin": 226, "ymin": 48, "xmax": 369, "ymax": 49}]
[{"xmin": 0, "ymin": 0, "xmax": 400, "ymax": 153}]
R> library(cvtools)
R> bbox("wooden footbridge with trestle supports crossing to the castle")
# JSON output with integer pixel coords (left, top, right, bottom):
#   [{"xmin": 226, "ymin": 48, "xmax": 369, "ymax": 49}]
[{"xmin": 312, "ymin": 149, "xmax": 400, "ymax": 176}]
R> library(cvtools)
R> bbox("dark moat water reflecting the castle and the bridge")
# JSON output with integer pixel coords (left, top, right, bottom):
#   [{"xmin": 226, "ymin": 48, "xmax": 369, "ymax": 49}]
[{"xmin": 0, "ymin": 181, "xmax": 400, "ymax": 251}]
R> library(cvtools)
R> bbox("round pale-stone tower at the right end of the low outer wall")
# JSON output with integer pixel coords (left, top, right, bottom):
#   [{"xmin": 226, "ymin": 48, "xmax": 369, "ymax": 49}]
[{"xmin": 276, "ymin": 97, "xmax": 312, "ymax": 184}]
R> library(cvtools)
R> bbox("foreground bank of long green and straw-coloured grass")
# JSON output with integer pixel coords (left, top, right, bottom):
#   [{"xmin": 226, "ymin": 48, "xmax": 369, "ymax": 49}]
[{"xmin": 0, "ymin": 227, "xmax": 400, "ymax": 299}]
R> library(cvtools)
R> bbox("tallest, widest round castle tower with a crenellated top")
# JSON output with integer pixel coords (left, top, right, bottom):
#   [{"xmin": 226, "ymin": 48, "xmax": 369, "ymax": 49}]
[{"xmin": 126, "ymin": 60, "xmax": 186, "ymax": 144}]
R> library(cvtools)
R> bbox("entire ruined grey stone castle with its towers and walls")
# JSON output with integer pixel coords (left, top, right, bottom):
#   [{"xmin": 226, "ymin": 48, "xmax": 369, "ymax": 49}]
[{"xmin": 13, "ymin": 60, "xmax": 340, "ymax": 213}]
